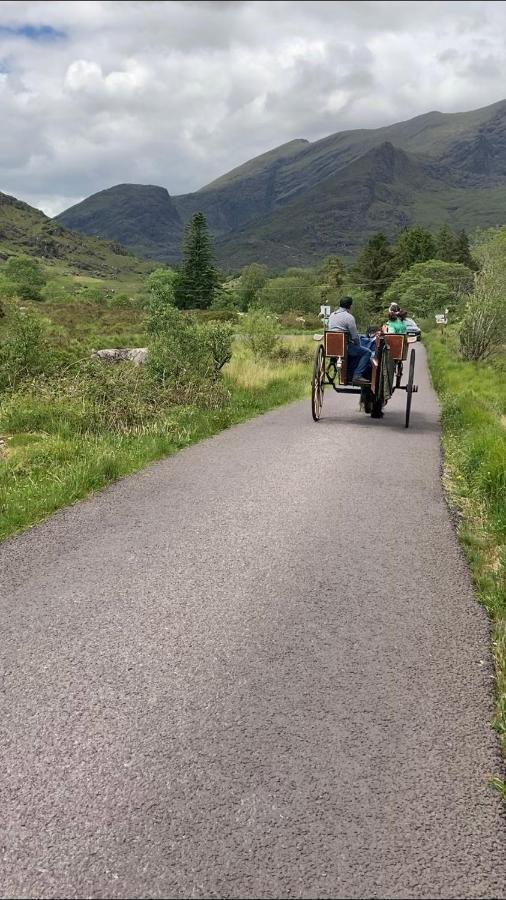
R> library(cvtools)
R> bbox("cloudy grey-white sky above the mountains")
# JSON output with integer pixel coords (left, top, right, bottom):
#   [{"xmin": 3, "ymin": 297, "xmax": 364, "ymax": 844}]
[{"xmin": 0, "ymin": 0, "xmax": 506, "ymax": 215}]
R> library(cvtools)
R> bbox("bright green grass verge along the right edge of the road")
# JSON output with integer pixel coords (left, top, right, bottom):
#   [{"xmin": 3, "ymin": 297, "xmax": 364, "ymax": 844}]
[{"xmin": 426, "ymin": 331, "xmax": 506, "ymax": 799}]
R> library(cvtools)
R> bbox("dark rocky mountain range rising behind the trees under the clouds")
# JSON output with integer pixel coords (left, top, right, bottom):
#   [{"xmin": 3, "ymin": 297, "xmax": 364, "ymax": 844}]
[{"xmin": 58, "ymin": 100, "xmax": 506, "ymax": 269}]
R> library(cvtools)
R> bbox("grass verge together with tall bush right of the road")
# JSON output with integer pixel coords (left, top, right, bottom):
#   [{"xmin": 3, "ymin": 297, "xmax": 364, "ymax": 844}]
[{"xmin": 426, "ymin": 228, "xmax": 506, "ymax": 799}]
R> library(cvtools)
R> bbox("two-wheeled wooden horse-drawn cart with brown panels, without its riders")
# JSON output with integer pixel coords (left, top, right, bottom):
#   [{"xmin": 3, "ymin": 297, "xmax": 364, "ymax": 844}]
[{"xmin": 311, "ymin": 331, "xmax": 418, "ymax": 428}]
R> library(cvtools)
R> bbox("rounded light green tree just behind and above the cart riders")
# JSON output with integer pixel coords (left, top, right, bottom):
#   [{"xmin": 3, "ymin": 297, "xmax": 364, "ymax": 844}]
[{"xmin": 383, "ymin": 259, "xmax": 474, "ymax": 316}]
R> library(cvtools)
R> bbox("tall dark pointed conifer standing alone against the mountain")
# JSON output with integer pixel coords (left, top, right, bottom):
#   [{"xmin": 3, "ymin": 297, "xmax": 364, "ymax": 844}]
[{"xmin": 175, "ymin": 212, "xmax": 217, "ymax": 309}]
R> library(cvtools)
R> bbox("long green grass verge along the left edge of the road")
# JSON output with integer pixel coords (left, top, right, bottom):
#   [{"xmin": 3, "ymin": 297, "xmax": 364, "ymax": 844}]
[{"xmin": 0, "ymin": 337, "xmax": 310, "ymax": 539}]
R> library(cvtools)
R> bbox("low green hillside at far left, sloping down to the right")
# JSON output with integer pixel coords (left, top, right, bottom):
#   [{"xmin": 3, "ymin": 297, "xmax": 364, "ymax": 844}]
[{"xmin": 0, "ymin": 193, "xmax": 153, "ymax": 277}]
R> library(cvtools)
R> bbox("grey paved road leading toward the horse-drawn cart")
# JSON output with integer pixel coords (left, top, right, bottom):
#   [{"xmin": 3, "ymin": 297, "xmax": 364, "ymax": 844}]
[{"xmin": 0, "ymin": 347, "xmax": 506, "ymax": 898}]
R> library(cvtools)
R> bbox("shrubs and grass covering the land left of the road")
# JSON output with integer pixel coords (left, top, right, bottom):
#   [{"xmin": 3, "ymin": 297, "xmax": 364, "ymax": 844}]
[{"xmin": 0, "ymin": 222, "xmax": 312, "ymax": 538}]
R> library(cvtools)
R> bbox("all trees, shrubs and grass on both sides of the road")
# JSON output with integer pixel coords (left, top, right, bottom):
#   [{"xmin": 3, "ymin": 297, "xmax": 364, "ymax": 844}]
[{"xmin": 0, "ymin": 214, "xmax": 506, "ymax": 780}]
